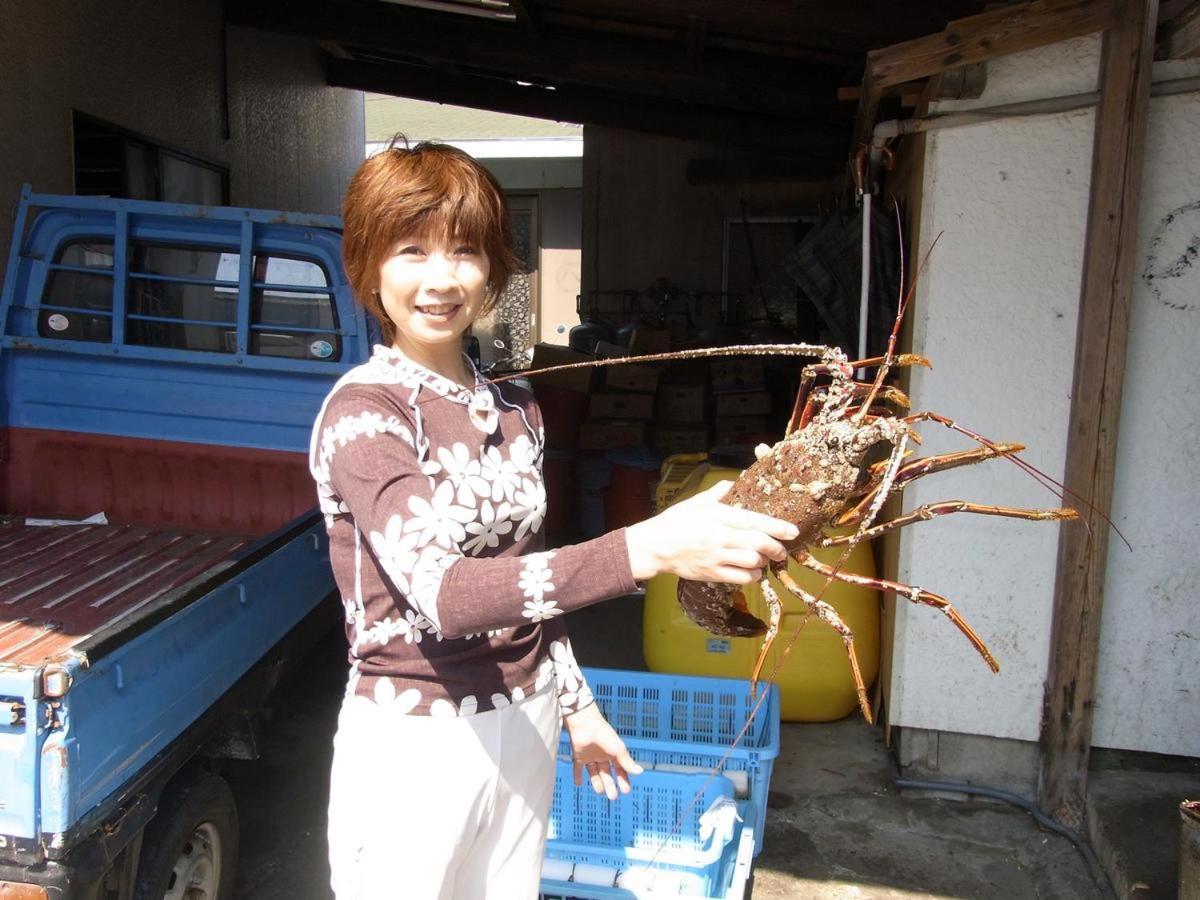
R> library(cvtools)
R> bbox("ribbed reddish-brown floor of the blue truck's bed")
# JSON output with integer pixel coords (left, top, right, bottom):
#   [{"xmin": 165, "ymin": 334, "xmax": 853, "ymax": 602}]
[{"xmin": 0, "ymin": 516, "xmax": 254, "ymax": 666}]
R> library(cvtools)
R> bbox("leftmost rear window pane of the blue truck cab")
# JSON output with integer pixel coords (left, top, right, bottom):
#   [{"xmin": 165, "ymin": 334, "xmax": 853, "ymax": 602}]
[{"xmin": 37, "ymin": 240, "xmax": 113, "ymax": 342}]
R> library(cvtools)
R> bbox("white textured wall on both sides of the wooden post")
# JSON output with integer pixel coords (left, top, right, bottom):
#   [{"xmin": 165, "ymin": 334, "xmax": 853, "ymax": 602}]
[{"xmin": 889, "ymin": 37, "xmax": 1200, "ymax": 754}]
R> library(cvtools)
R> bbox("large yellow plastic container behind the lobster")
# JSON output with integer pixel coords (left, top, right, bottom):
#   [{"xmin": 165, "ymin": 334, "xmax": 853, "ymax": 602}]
[{"xmin": 642, "ymin": 455, "xmax": 880, "ymax": 722}]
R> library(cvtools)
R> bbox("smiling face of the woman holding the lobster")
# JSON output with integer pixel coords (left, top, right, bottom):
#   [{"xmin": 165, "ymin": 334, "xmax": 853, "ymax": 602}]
[{"xmin": 379, "ymin": 235, "xmax": 491, "ymax": 352}]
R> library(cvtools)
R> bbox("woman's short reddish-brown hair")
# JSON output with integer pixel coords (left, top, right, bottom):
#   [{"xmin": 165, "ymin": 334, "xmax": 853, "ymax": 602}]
[{"xmin": 342, "ymin": 138, "xmax": 520, "ymax": 344}]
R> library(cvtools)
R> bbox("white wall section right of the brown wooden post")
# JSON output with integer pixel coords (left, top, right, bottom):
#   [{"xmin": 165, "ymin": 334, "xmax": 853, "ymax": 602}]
[{"xmin": 1092, "ymin": 75, "xmax": 1200, "ymax": 756}]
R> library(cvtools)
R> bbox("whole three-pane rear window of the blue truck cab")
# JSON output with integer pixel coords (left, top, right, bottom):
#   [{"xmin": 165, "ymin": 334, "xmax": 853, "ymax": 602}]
[{"xmin": 38, "ymin": 240, "xmax": 342, "ymax": 362}]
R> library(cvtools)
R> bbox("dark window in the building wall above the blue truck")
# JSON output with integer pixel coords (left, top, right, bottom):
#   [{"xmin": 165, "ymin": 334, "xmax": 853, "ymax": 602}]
[{"xmin": 74, "ymin": 113, "xmax": 229, "ymax": 206}]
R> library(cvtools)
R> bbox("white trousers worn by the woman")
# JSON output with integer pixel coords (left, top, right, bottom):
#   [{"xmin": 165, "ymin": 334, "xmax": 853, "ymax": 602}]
[{"xmin": 329, "ymin": 689, "xmax": 562, "ymax": 900}]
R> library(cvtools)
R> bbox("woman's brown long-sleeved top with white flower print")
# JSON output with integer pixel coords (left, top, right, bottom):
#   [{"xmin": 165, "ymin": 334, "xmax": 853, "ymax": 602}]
[{"xmin": 310, "ymin": 347, "xmax": 636, "ymax": 715}]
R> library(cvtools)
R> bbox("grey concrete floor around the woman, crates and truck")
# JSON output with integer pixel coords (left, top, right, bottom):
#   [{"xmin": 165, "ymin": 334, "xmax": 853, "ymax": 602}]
[{"xmin": 226, "ymin": 599, "xmax": 1161, "ymax": 900}]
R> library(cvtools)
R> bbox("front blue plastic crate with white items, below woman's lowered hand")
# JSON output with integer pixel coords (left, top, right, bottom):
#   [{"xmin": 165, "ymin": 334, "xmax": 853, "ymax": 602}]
[{"xmin": 541, "ymin": 761, "xmax": 755, "ymax": 900}]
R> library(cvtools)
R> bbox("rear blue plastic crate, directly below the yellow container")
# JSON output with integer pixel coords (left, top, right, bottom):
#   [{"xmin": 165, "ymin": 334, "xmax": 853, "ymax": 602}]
[{"xmin": 559, "ymin": 667, "xmax": 779, "ymax": 856}]
